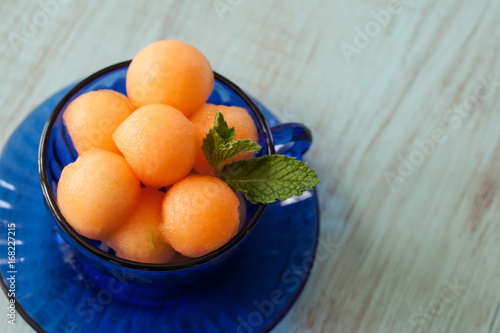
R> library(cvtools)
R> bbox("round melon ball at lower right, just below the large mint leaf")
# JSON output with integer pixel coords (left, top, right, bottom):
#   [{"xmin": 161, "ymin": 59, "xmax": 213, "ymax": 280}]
[{"xmin": 159, "ymin": 176, "xmax": 240, "ymax": 258}]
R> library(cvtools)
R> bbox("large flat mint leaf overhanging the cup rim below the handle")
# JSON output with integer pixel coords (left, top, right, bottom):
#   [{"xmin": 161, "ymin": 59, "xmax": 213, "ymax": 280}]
[{"xmin": 220, "ymin": 155, "xmax": 320, "ymax": 204}]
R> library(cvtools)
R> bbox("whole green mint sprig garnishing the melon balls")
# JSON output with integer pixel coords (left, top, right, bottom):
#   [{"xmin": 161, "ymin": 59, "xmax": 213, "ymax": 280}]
[{"xmin": 201, "ymin": 110, "xmax": 320, "ymax": 204}]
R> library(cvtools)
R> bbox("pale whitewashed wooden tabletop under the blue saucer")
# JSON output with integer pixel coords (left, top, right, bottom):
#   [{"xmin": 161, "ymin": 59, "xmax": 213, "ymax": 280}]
[{"xmin": 0, "ymin": 0, "xmax": 500, "ymax": 333}]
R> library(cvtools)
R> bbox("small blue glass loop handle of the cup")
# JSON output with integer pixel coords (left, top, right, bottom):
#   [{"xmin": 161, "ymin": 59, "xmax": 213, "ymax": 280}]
[{"xmin": 271, "ymin": 123, "xmax": 312, "ymax": 159}]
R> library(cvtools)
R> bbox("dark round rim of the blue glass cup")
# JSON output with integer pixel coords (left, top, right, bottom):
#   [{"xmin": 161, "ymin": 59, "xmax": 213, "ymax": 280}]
[{"xmin": 38, "ymin": 60, "xmax": 275, "ymax": 272}]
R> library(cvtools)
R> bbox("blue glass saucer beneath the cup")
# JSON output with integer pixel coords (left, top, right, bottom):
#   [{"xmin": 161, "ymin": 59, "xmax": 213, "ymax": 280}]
[{"xmin": 0, "ymin": 87, "xmax": 319, "ymax": 333}]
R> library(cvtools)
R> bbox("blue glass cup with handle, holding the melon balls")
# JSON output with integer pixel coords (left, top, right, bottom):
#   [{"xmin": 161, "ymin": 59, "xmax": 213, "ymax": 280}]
[{"xmin": 38, "ymin": 61, "xmax": 311, "ymax": 297}]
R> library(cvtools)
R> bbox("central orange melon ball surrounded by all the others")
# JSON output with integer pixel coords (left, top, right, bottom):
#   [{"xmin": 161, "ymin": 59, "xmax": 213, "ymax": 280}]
[{"xmin": 113, "ymin": 104, "xmax": 198, "ymax": 187}]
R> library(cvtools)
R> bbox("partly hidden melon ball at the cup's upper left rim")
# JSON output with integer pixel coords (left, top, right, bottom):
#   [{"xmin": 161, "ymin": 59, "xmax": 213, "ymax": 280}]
[{"xmin": 63, "ymin": 90, "xmax": 135, "ymax": 154}]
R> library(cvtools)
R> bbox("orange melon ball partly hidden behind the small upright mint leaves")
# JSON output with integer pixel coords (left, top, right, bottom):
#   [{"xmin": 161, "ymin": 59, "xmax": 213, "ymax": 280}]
[{"xmin": 189, "ymin": 103, "xmax": 259, "ymax": 175}]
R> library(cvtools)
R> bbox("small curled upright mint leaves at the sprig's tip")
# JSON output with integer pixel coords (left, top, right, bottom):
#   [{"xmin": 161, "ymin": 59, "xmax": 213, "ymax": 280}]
[{"xmin": 201, "ymin": 110, "xmax": 262, "ymax": 172}]
